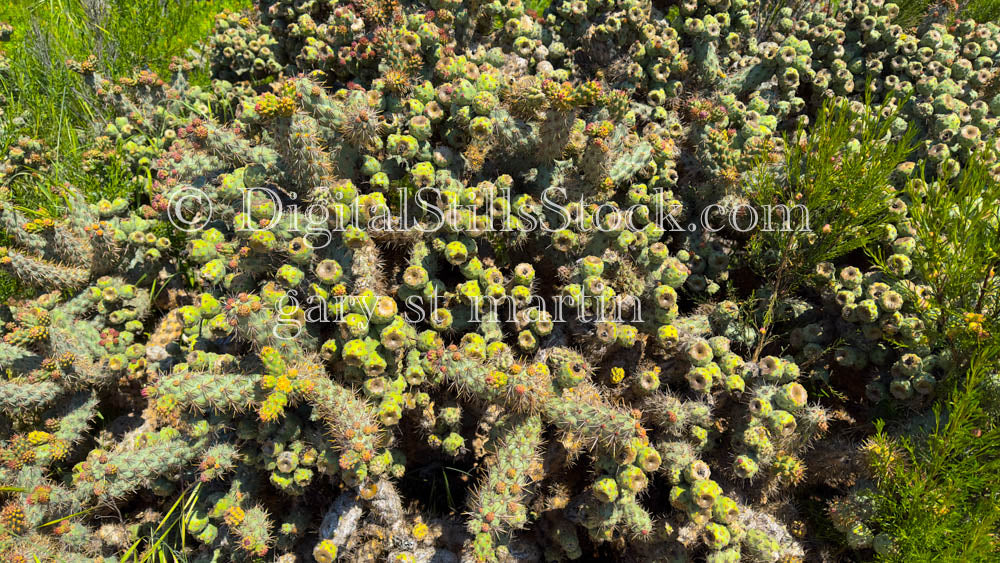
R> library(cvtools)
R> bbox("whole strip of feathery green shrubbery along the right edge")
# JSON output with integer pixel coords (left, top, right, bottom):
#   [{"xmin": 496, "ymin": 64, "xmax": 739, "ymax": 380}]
[{"xmin": 867, "ymin": 143, "xmax": 1000, "ymax": 561}]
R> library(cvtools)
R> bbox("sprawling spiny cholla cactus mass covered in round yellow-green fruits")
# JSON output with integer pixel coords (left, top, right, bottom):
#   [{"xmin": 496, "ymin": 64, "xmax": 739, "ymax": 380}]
[{"xmin": 0, "ymin": 0, "xmax": 1000, "ymax": 563}]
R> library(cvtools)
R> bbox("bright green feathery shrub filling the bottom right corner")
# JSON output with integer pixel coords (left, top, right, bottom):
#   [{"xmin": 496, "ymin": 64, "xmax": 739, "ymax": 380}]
[{"xmin": 866, "ymin": 350, "xmax": 1000, "ymax": 562}]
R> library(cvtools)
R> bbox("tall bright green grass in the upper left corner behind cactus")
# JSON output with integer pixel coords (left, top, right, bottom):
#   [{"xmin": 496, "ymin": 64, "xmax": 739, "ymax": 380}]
[{"xmin": 0, "ymin": 0, "xmax": 251, "ymax": 299}]
